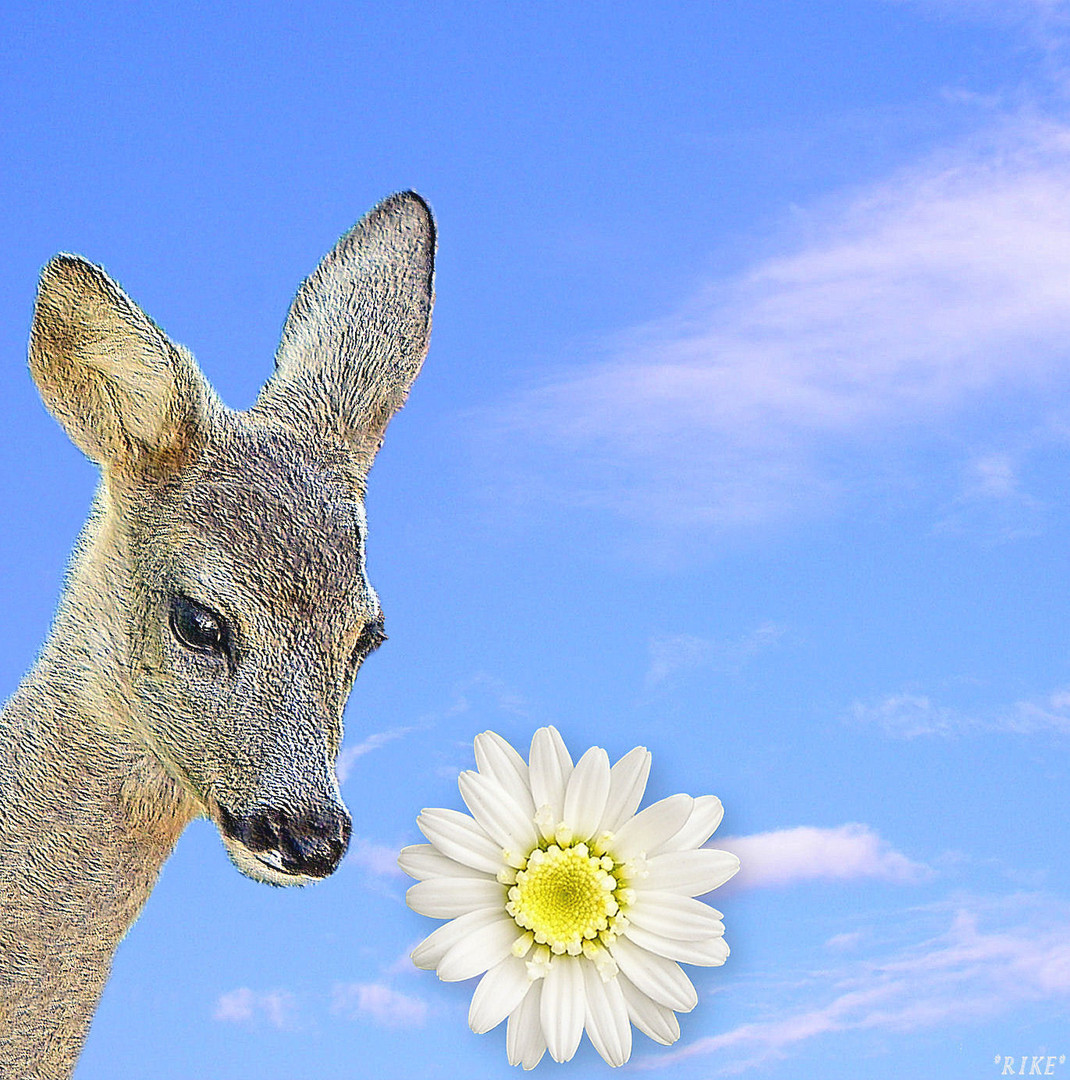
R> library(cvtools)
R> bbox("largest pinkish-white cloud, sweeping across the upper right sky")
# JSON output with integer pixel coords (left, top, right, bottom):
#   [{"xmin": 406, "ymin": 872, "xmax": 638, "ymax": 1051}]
[{"xmin": 492, "ymin": 117, "xmax": 1070, "ymax": 535}]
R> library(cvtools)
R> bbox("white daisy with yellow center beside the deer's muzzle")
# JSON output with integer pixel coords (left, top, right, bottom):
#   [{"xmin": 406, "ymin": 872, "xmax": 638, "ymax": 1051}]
[{"xmin": 398, "ymin": 728, "xmax": 740, "ymax": 1069}]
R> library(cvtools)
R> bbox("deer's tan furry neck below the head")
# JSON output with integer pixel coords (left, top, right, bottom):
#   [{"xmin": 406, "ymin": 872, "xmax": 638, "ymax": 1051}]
[{"xmin": 0, "ymin": 494, "xmax": 197, "ymax": 1080}]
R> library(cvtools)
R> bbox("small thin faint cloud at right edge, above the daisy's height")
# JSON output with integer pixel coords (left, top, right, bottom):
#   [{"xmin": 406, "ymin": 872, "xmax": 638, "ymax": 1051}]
[{"xmin": 848, "ymin": 688, "xmax": 1070, "ymax": 739}]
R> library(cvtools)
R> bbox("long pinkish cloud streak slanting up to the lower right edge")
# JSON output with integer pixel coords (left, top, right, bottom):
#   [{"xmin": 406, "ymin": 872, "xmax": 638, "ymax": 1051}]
[{"xmin": 645, "ymin": 895, "xmax": 1070, "ymax": 1075}]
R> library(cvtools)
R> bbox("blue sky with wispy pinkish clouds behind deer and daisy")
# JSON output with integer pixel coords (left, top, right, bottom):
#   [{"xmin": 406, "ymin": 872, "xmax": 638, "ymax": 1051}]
[{"xmin": 0, "ymin": 0, "xmax": 1070, "ymax": 1080}]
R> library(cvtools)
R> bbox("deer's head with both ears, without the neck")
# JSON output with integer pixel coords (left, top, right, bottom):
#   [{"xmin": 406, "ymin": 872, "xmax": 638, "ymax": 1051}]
[{"xmin": 30, "ymin": 193, "xmax": 435, "ymax": 885}]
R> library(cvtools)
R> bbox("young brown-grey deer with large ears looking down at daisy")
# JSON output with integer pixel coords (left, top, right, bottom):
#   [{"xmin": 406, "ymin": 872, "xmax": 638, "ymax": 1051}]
[{"xmin": 0, "ymin": 192, "xmax": 435, "ymax": 1080}]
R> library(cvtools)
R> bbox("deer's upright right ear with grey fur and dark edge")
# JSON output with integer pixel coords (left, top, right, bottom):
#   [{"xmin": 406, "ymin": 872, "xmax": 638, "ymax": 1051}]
[{"xmin": 253, "ymin": 191, "xmax": 435, "ymax": 470}]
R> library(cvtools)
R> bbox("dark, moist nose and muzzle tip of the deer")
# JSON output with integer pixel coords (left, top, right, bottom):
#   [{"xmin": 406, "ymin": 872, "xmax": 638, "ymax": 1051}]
[{"xmin": 220, "ymin": 806, "xmax": 353, "ymax": 878}]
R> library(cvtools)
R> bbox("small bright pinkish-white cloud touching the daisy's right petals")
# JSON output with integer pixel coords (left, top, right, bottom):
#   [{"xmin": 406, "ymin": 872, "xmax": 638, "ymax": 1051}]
[{"xmin": 715, "ymin": 824, "xmax": 929, "ymax": 889}]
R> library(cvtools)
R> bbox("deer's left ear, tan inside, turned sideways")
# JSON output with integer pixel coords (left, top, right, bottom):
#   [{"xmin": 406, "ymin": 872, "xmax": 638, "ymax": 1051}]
[{"xmin": 29, "ymin": 255, "xmax": 213, "ymax": 465}]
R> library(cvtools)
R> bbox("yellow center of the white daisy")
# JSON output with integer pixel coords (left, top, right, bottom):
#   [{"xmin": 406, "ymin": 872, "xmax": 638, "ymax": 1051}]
[{"xmin": 505, "ymin": 843, "xmax": 625, "ymax": 956}]
